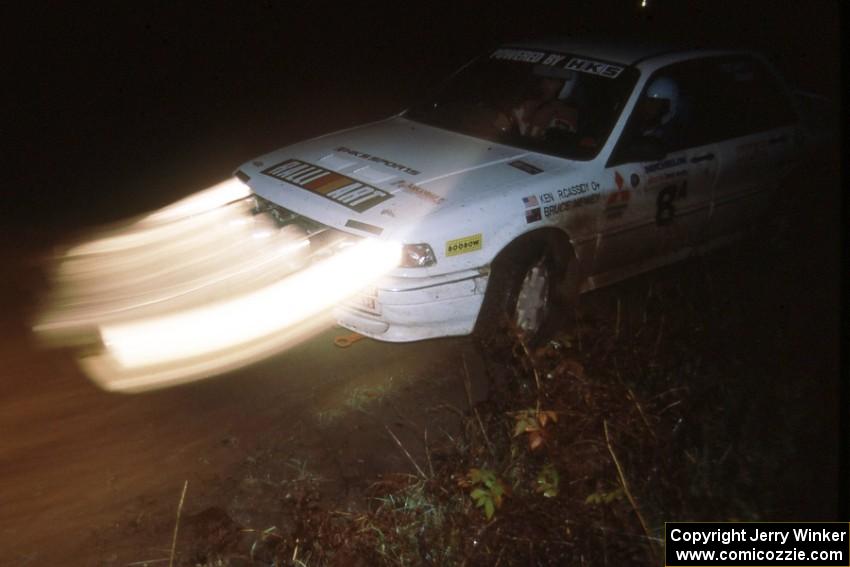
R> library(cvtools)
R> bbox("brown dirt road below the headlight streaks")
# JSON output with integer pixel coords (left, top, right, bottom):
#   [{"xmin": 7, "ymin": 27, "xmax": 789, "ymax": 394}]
[{"xmin": 0, "ymin": 248, "xmax": 484, "ymax": 565}]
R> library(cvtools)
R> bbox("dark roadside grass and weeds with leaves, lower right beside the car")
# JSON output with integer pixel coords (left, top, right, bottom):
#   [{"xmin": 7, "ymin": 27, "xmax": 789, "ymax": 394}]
[{"xmin": 166, "ymin": 202, "xmax": 836, "ymax": 565}]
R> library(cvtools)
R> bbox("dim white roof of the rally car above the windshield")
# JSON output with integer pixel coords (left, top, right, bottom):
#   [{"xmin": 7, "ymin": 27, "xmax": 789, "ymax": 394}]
[{"xmin": 505, "ymin": 37, "xmax": 715, "ymax": 65}]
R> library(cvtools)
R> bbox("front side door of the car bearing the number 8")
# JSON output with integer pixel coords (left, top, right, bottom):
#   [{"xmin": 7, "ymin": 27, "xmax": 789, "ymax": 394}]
[{"xmin": 594, "ymin": 60, "xmax": 719, "ymax": 279}]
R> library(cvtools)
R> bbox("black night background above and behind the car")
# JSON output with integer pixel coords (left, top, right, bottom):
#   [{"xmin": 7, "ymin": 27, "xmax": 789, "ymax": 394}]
[{"xmin": 6, "ymin": 0, "xmax": 840, "ymax": 235}]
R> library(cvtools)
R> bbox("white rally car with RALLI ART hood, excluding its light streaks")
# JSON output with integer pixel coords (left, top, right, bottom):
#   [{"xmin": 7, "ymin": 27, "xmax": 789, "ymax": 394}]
[{"xmin": 236, "ymin": 40, "xmax": 820, "ymax": 341}]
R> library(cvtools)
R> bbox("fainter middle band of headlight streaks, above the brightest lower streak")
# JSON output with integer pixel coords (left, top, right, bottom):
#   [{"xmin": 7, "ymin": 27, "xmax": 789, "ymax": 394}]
[{"xmin": 35, "ymin": 201, "xmax": 310, "ymax": 336}]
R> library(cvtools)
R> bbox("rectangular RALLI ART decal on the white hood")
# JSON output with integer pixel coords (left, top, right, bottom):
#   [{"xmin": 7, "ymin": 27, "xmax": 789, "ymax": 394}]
[{"xmin": 262, "ymin": 159, "xmax": 392, "ymax": 213}]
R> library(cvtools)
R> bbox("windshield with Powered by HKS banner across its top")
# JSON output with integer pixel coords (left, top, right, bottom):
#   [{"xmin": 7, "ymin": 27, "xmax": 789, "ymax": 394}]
[{"xmin": 405, "ymin": 48, "xmax": 638, "ymax": 160}]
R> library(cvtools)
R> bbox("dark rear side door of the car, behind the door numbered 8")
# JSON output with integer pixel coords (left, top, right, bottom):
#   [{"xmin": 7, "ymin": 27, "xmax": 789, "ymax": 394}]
[{"xmin": 696, "ymin": 55, "xmax": 796, "ymax": 244}]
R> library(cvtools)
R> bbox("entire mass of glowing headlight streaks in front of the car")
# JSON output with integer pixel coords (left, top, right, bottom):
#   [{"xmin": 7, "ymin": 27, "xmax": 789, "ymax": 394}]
[{"xmin": 34, "ymin": 179, "xmax": 402, "ymax": 392}]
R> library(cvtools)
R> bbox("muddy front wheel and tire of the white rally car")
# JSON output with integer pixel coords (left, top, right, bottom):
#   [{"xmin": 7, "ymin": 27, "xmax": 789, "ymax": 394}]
[{"xmin": 475, "ymin": 240, "xmax": 560, "ymax": 345}]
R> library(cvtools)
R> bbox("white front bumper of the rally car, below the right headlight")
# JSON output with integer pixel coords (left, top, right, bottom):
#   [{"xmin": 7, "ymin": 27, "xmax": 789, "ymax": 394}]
[{"xmin": 334, "ymin": 268, "xmax": 489, "ymax": 342}]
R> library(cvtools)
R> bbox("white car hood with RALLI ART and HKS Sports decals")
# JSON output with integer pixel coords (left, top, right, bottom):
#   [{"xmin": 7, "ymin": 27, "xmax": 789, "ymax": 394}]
[{"xmin": 235, "ymin": 117, "xmax": 573, "ymax": 240}]
